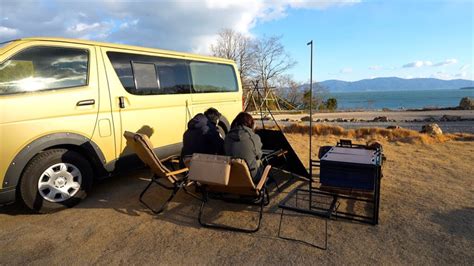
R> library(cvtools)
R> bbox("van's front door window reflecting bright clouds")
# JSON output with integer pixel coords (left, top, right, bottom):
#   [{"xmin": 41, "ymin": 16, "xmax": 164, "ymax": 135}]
[{"xmin": 0, "ymin": 46, "xmax": 89, "ymax": 95}]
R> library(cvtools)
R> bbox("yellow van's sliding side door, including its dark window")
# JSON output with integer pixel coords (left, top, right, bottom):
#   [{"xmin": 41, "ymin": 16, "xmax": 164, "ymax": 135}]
[{"xmin": 103, "ymin": 49, "xmax": 191, "ymax": 157}]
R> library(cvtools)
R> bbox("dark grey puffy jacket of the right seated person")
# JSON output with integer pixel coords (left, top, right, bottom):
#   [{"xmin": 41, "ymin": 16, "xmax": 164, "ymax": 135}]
[{"xmin": 224, "ymin": 126, "xmax": 262, "ymax": 182}]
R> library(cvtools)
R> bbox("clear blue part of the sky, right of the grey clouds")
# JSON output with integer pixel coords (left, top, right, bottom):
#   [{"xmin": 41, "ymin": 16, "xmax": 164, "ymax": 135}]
[{"xmin": 253, "ymin": 1, "xmax": 474, "ymax": 80}]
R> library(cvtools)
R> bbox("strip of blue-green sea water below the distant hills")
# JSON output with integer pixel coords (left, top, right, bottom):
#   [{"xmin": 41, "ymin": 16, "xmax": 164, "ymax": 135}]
[{"xmin": 327, "ymin": 89, "xmax": 474, "ymax": 110}]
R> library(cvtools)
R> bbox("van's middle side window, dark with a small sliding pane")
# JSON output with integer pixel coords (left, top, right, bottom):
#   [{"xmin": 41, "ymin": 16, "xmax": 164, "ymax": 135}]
[{"xmin": 107, "ymin": 52, "xmax": 191, "ymax": 95}]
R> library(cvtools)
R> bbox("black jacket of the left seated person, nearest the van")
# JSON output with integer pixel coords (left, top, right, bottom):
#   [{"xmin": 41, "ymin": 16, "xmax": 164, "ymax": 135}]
[{"xmin": 181, "ymin": 114, "xmax": 224, "ymax": 158}]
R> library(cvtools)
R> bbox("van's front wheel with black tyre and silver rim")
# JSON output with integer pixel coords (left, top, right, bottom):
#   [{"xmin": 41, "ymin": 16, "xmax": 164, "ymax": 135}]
[{"xmin": 20, "ymin": 149, "xmax": 93, "ymax": 213}]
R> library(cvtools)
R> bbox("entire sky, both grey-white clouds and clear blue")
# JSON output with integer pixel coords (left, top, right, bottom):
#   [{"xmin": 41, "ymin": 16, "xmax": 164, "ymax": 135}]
[{"xmin": 0, "ymin": 0, "xmax": 474, "ymax": 82}]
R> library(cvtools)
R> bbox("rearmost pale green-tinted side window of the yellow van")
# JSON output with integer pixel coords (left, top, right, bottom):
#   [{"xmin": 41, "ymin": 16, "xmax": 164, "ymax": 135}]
[{"xmin": 189, "ymin": 61, "xmax": 238, "ymax": 93}]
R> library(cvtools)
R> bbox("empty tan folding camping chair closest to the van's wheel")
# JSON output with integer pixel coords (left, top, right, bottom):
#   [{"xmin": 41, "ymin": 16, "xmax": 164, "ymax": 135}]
[{"xmin": 123, "ymin": 131, "xmax": 188, "ymax": 214}]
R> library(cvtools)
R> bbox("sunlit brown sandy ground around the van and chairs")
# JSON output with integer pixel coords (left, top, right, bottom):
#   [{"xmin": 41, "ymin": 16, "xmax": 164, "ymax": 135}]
[{"xmin": 0, "ymin": 134, "xmax": 474, "ymax": 265}]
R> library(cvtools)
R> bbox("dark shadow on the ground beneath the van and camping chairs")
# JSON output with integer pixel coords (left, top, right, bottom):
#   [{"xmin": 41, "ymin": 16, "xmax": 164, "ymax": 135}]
[{"xmin": 0, "ymin": 169, "xmax": 300, "ymax": 227}]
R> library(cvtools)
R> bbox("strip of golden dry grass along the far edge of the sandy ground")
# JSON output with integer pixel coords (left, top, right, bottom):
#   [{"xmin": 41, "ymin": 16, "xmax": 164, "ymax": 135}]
[{"xmin": 283, "ymin": 123, "xmax": 474, "ymax": 144}]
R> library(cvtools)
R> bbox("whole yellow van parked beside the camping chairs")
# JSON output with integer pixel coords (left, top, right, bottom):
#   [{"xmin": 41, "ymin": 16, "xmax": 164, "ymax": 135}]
[{"xmin": 0, "ymin": 38, "xmax": 242, "ymax": 212}]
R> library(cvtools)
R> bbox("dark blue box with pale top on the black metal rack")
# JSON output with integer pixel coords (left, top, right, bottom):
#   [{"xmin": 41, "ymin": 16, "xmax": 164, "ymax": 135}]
[{"xmin": 320, "ymin": 147, "xmax": 382, "ymax": 191}]
